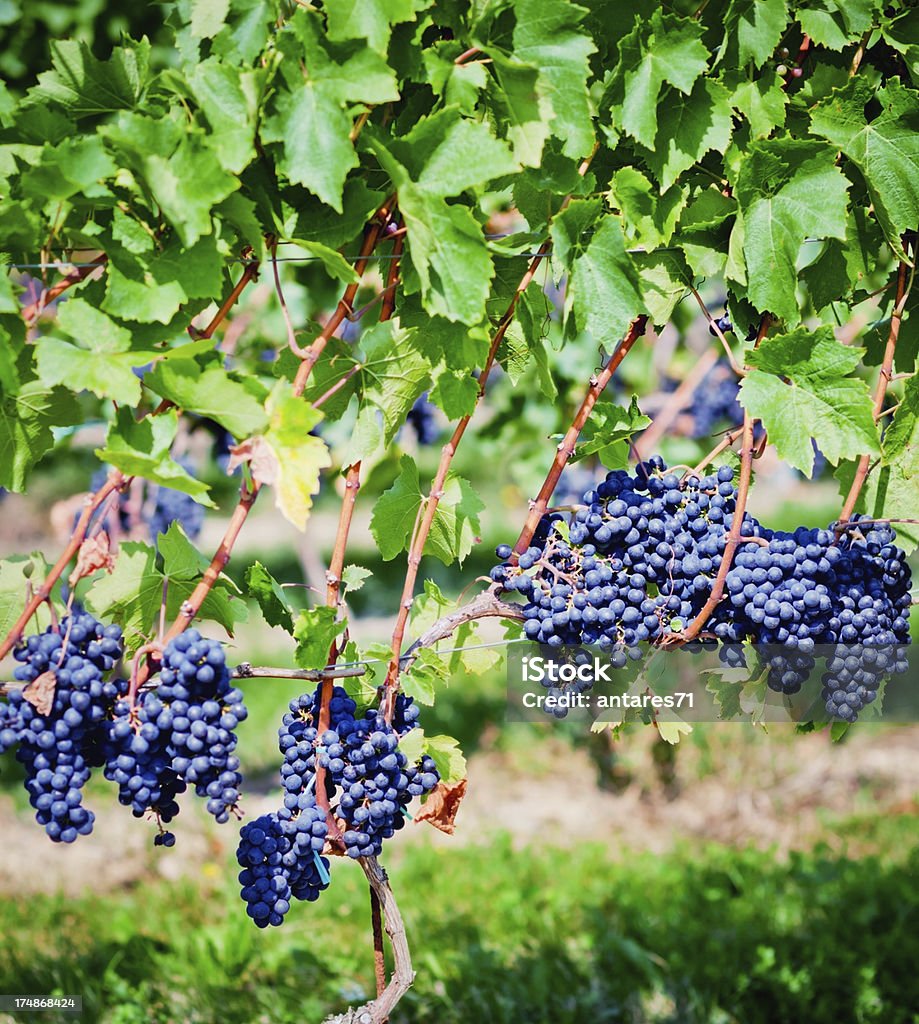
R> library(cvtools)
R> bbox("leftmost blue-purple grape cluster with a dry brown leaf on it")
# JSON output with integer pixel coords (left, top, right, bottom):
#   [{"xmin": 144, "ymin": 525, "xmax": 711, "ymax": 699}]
[{"xmin": 0, "ymin": 612, "xmax": 125, "ymax": 843}]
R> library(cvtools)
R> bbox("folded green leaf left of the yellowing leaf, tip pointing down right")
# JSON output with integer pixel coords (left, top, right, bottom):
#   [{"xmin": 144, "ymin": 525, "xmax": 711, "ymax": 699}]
[{"xmin": 95, "ymin": 409, "xmax": 216, "ymax": 508}]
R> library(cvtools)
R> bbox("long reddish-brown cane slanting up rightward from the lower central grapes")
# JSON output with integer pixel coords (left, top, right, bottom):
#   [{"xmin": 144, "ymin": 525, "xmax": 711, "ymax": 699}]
[{"xmin": 383, "ymin": 241, "xmax": 551, "ymax": 722}]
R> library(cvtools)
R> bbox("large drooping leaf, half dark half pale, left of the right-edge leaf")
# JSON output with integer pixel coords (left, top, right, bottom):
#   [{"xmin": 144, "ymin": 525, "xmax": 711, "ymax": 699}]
[{"xmin": 732, "ymin": 140, "xmax": 848, "ymax": 327}]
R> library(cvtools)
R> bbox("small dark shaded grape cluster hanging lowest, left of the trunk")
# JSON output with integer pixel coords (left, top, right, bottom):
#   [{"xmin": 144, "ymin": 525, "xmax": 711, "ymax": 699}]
[{"xmin": 237, "ymin": 801, "xmax": 329, "ymax": 928}]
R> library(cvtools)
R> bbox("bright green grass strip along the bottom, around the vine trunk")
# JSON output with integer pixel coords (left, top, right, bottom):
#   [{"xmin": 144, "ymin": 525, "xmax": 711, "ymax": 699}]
[{"xmin": 0, "ymin": 817, "xmax": 919, "ymax": 1024}]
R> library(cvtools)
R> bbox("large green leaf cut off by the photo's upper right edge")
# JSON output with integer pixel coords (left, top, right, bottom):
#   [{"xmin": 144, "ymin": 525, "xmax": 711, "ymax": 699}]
[{"xmin": 810, "ymin": 78, "xmax": 919, "ymax": 258}]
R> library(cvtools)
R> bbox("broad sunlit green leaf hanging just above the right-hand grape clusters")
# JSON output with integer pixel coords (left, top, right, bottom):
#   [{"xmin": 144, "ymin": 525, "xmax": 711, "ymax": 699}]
[{"xmin": 740, "ymin": 327, "xmax": 880, "ymax": 476}]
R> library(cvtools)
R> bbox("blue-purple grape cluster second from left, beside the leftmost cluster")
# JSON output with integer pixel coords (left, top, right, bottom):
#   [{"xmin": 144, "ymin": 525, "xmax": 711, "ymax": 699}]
[{"xmin": 106, "ymin": 630, "xmax": 247, "ymax": 845}]
